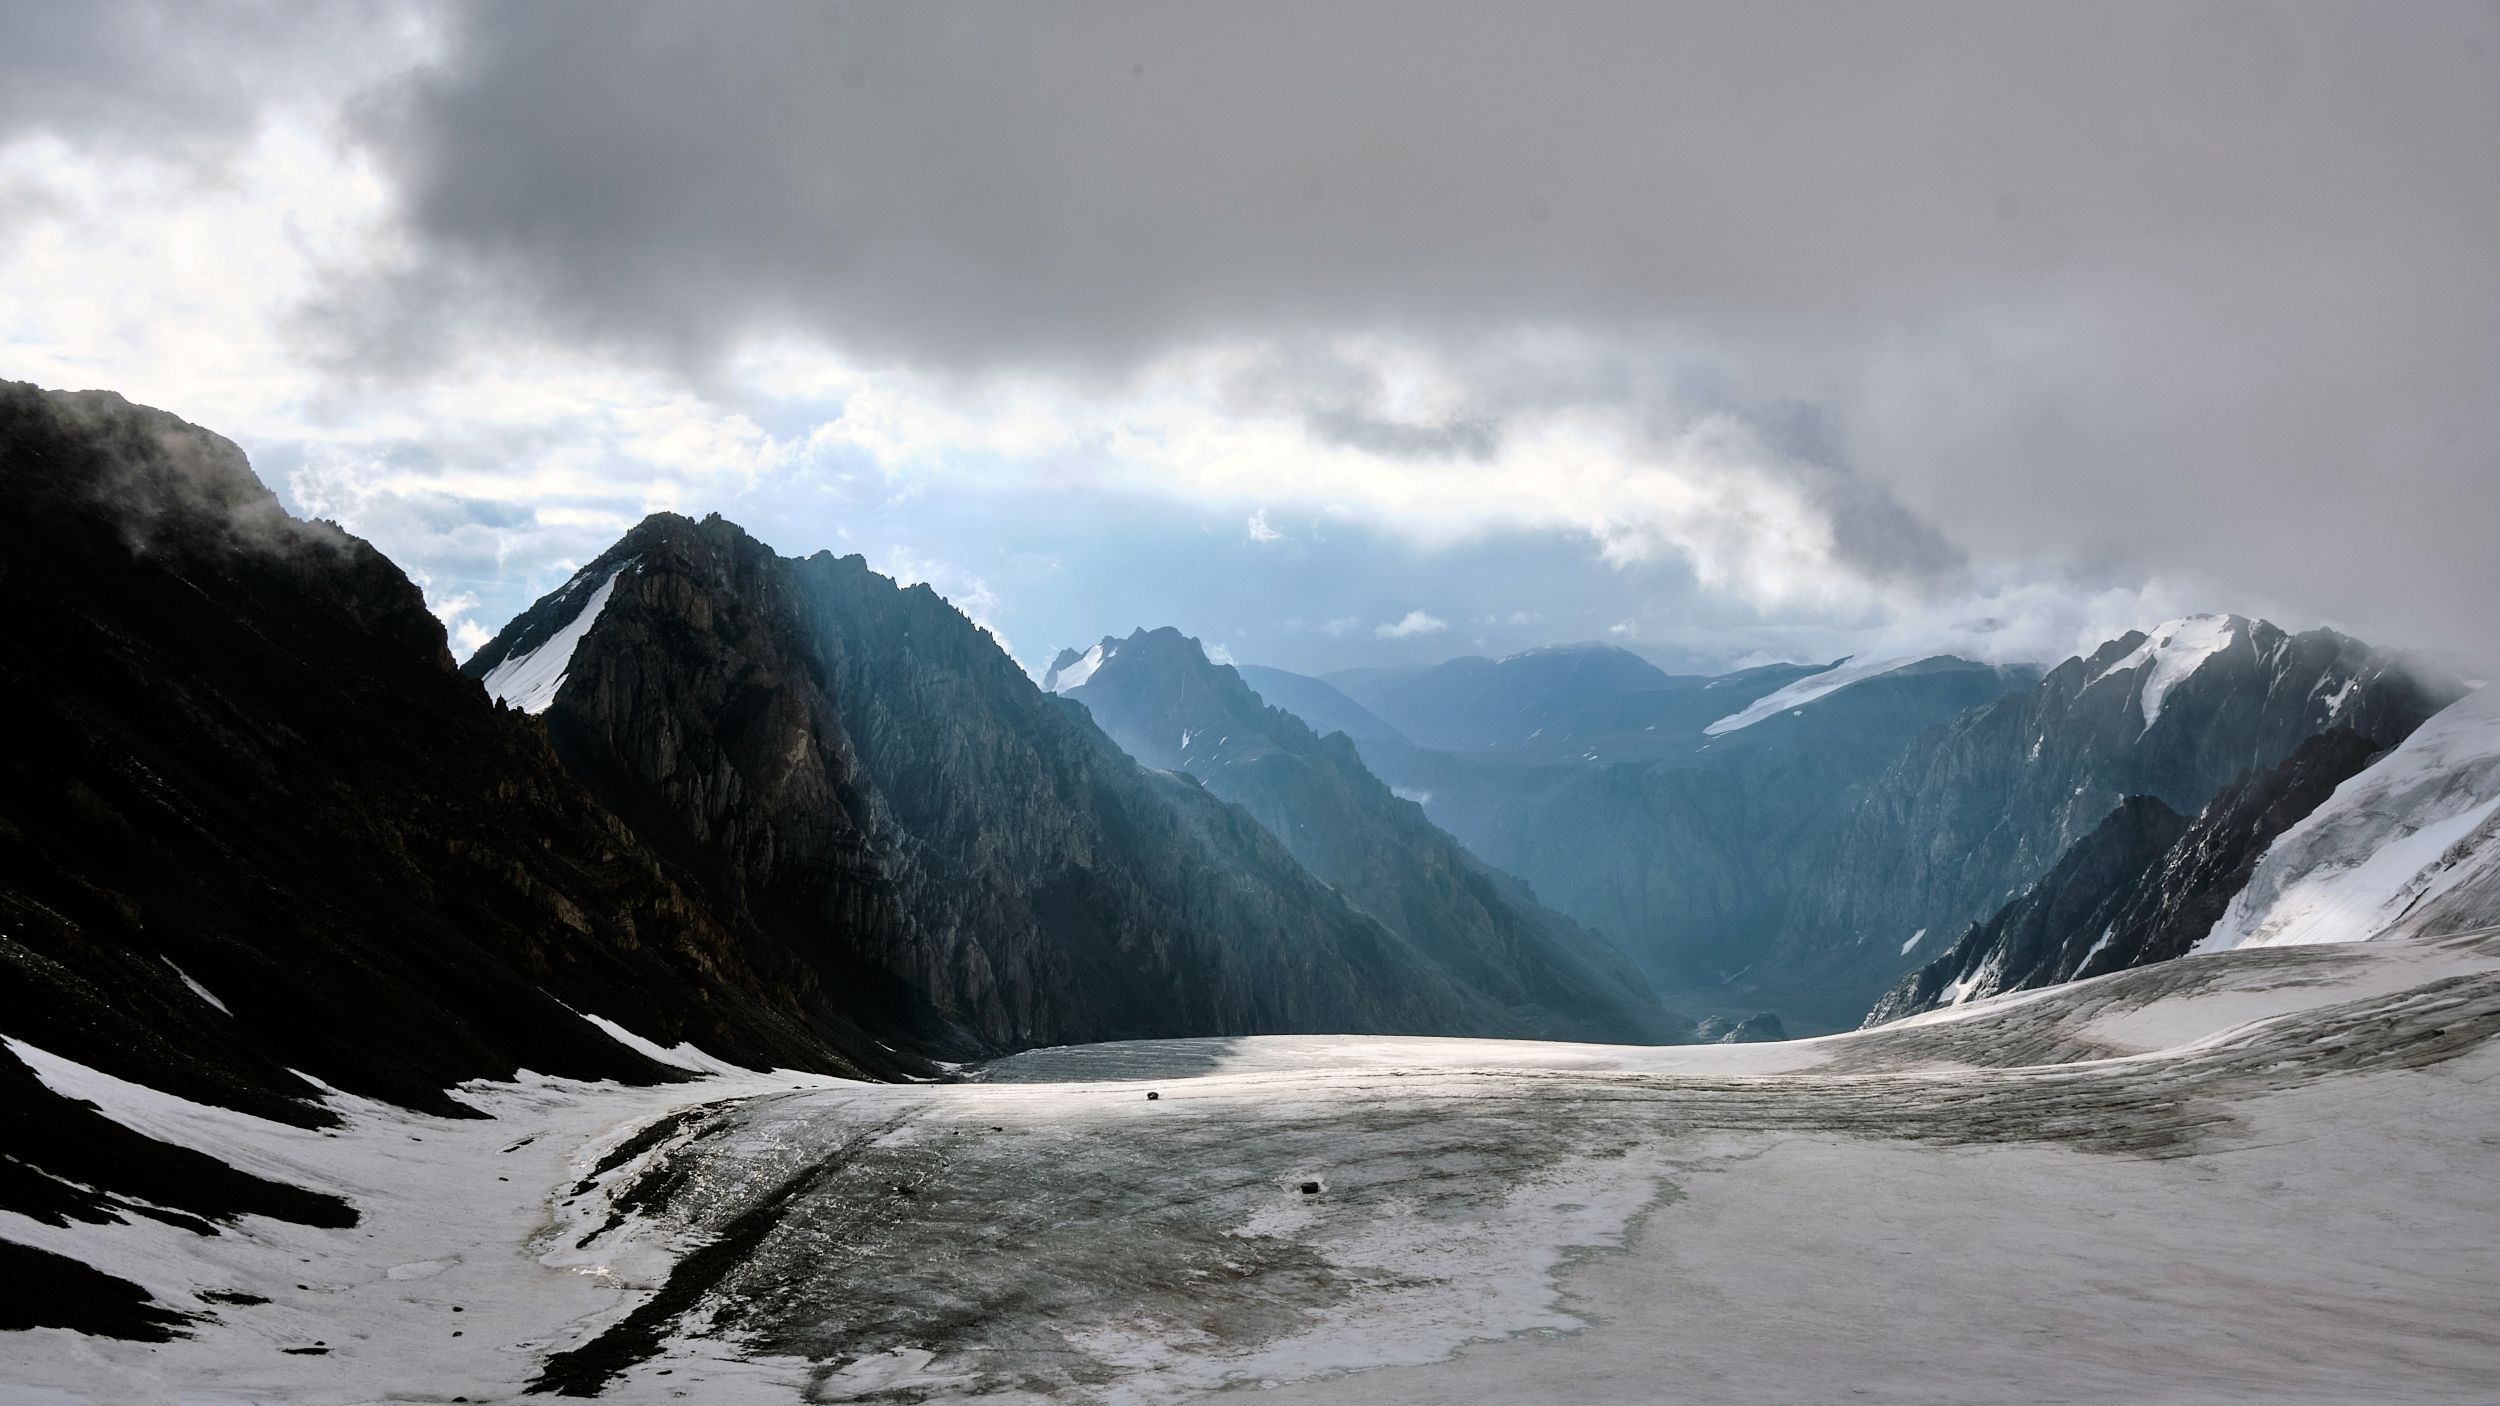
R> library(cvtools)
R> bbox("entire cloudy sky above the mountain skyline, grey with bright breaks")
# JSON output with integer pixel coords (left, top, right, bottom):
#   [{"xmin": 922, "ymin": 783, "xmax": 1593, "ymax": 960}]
[{"xmin": 0, "ymin": 0, "xmax": 2500, "ymax": 670}]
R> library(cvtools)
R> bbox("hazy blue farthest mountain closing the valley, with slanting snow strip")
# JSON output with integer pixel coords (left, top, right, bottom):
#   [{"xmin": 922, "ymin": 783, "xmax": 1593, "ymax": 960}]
[{"xmin": 1270, "ymin": 650, "xmax": 2038, "ymax": 1015}]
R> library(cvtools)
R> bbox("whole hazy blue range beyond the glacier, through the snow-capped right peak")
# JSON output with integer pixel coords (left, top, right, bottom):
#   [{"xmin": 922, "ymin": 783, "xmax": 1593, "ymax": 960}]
[{"xmin": 1210, "ymin": 615, "xmax": 2463, "ymax": 1031}]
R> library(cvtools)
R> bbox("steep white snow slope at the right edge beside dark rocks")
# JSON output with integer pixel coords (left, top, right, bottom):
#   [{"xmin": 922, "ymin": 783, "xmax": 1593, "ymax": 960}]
[{"xmin": 2198, "ymin": 688, "xmax": 2500, "ymax": 951}]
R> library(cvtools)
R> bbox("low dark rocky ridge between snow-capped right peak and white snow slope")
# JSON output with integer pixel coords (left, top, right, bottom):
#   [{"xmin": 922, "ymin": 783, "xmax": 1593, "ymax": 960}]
[{"xmin": 1868, "ymin": 728, "xmax": 2380, "ymax": 1026}]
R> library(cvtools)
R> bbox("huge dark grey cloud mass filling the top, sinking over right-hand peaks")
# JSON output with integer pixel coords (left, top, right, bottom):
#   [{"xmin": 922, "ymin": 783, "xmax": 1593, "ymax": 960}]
[{"xmin": 19, "ymin": 0, "xmax": 2500, "ymax": 645}]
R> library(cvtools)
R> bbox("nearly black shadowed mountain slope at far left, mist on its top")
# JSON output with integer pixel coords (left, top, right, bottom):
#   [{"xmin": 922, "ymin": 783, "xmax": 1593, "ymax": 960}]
[{"xmin": 0, "ymin": 383, "xmax": 910, "ymax": 1331}]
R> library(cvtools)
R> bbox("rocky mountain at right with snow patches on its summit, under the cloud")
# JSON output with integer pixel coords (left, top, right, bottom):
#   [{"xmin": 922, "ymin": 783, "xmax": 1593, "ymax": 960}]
[{"xmin": 1773, "ymin": 615, "xmax": 2460, "ymax": 998}]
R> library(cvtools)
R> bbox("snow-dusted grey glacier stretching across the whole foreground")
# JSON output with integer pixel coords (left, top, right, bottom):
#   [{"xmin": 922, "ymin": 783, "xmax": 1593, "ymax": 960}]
[{"xmin": 0, "ymin": 933, "xmax": 2500, "ymax": 1403}]
